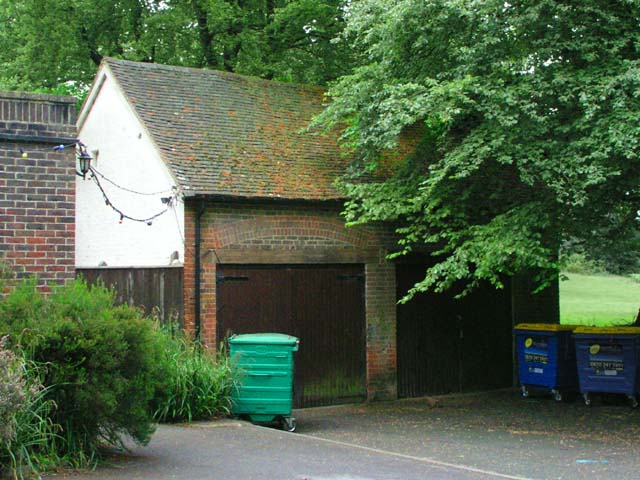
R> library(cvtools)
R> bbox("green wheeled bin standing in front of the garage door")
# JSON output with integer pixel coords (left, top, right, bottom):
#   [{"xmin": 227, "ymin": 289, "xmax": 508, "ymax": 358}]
[{"xmin": 229, "ymin": 333, "xmax": 300, "ymax": 432}]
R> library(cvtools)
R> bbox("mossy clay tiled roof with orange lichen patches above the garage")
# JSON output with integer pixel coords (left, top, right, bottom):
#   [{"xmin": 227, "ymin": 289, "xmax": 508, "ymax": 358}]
[{"xmin": 105, "ymin": 58, "xmax": 347, "ymax": 200}]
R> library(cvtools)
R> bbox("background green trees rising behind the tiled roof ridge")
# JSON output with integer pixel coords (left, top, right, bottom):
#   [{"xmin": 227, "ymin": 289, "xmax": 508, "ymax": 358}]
[{"xmin": 0, "ymin": 0, "xmax": 350, "ymax": 90}]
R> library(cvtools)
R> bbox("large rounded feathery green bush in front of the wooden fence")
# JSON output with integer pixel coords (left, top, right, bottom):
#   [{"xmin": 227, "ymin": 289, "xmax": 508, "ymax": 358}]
[{"xmin": 0, "ymin": 280, "xmax": 166, "ymax": 465}]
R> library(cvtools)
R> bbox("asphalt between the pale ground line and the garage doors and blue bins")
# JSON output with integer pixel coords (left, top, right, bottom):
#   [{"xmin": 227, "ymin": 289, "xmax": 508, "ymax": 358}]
[{"xmin": 298, "ymin": 390, "xmax": 640, "ymax": 479}]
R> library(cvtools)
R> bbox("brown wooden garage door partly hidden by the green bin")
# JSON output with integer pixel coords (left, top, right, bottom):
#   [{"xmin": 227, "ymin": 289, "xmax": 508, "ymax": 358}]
[{"xmin": 216, "ymin": 265, "xmax": 366, "ymax": 407}]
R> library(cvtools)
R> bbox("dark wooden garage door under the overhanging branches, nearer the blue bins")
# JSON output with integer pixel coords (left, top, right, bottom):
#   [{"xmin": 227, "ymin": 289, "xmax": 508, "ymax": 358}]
[{"xmin": 396, "ymin": 265, "xmax": 513, "ymax": 397}]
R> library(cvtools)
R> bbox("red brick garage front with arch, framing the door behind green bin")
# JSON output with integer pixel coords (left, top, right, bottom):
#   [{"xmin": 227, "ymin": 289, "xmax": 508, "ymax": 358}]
[{"xmin": 184, "ymin": 201, "xmax": 397, "ymax": 399}]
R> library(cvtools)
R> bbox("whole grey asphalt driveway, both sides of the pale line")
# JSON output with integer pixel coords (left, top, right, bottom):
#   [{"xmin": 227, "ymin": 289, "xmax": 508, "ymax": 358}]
[{"xmin": 48, "ymin": 390, "xmax": 640, "ymax": 480}]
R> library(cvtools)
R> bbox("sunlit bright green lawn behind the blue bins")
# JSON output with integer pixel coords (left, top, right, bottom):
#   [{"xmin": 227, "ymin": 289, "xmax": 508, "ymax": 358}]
[{"xmin": 560, "ymin": 273, "xmax": 640, "ymax": 326}]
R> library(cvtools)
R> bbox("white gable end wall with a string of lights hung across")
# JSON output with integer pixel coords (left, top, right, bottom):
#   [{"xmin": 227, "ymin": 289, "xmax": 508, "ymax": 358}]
[{"xmin": 76, "ymin": 69, "xmax": 184, "ymax": 268}]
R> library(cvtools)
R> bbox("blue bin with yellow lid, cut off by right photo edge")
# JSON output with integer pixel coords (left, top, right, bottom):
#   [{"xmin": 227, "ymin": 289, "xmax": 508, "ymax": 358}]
[{"xmin": 573, "ymin": 327, "xmax": 640, "ymax": 408}]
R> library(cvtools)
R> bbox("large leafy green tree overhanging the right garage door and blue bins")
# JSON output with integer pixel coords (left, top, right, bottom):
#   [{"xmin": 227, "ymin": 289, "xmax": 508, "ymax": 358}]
[{"xmin": 317, "ymin": 0, "xmax": 640, "ymax": 290}]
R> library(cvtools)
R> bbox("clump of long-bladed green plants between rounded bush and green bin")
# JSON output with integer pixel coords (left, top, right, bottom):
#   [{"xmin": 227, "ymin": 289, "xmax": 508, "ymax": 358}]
[{"xmin": 155, "ymin": 327, "xmax": 233, "ymax": 422}]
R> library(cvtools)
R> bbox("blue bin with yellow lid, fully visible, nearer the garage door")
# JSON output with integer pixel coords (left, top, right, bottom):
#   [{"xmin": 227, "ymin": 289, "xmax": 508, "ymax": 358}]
[{"xmin": 513, "ymin": 323, "xmax": 578, "ymax": 402}]
